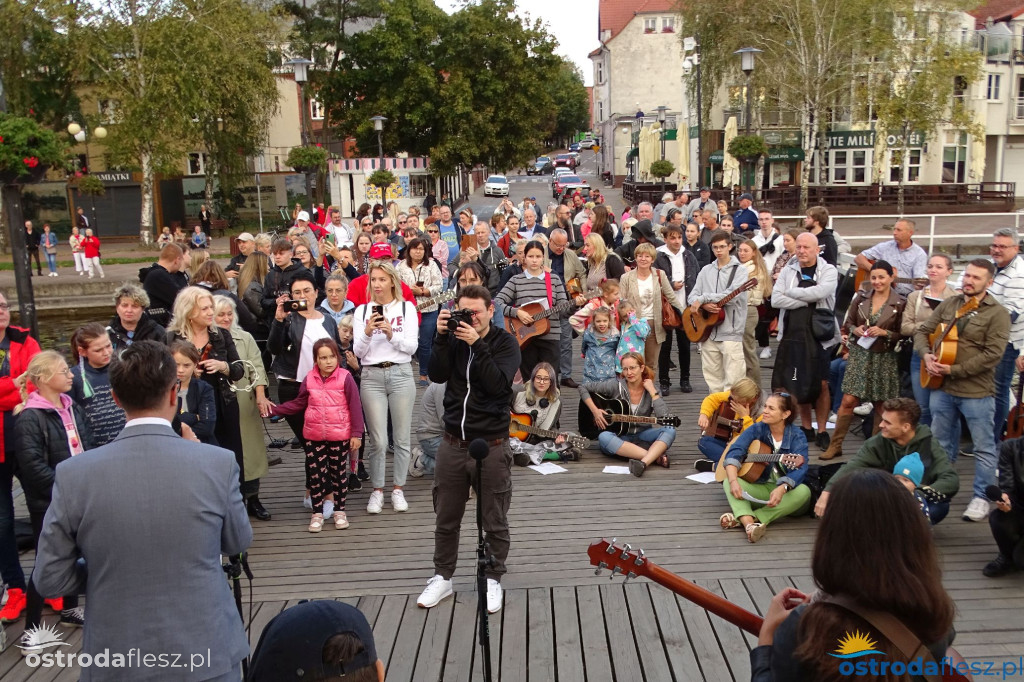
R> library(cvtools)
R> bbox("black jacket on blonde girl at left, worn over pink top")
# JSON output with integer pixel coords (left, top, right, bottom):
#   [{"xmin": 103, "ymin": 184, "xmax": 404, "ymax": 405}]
[{"xmin": 13, "ymin": 404, "xmax": 92, "ymax": 514}]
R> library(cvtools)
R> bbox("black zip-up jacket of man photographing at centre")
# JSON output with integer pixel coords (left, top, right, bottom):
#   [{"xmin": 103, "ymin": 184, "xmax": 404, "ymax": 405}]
[{"xmin": 428, "ymin": 325, "xmax": 521, "ymax": 440}]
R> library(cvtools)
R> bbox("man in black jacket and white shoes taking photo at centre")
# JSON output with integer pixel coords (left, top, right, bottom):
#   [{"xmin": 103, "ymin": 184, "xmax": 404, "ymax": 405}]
[{"xmin": 417, "ymin": 285, "xmax": 520, "ymax": 613}]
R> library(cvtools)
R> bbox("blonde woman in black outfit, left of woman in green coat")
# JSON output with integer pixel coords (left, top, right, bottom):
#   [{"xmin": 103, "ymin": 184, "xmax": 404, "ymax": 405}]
[{"xmin": 167, "ymin": 287, "xmax": 245, "ymax": 485}]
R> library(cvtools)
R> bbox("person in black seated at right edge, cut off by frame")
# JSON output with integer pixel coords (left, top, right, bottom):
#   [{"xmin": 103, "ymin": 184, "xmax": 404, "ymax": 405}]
[{"xmin": 981, "ymin": 430, "xmax": 1024, "ymax": 578}]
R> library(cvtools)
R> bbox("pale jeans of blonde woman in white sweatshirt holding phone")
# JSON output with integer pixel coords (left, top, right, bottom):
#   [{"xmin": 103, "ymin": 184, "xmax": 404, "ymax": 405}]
[{"xmin": 359, "ymin": 363, "xmax": 416, "ymax": 488}]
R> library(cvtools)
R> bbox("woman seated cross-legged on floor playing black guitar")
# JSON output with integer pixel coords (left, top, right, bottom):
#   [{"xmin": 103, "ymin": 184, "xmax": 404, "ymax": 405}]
[{"xmin": 580, "ymin": 352, "xmax": 676, "ymax": 477}]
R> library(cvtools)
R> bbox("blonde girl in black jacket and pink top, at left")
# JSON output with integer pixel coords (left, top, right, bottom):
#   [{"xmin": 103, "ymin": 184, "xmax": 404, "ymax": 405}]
[{"xmin": 11, "ymin": 350, "xmax": 93, "ymax": 638}]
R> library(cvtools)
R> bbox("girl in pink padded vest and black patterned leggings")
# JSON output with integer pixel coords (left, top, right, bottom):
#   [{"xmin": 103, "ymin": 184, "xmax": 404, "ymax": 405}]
[{"xmin": 263, "ymin": 339, "xmax": 362, "ymax": 532}]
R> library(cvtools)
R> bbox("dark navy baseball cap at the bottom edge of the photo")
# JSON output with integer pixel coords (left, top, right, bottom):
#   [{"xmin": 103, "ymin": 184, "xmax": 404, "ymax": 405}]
[{"xmin": 248, "ymin": 599, "xmax": 377, "ymax": 682}]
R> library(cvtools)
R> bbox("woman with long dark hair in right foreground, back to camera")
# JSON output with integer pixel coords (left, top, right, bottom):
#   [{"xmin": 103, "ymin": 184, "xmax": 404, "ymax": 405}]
[{"xmin": 751, "ymin": 470, "xmax": 955, "ymax": 682}]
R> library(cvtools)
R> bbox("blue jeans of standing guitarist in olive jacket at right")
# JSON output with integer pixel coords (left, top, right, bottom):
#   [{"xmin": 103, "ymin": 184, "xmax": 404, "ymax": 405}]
[{"xmin": 930, "ymin": 390, "xmax": 996, "ymax": 500}]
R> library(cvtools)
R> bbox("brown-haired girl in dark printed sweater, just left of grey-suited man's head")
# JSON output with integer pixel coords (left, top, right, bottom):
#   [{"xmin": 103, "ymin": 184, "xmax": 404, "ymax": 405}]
[{"xmin": 70, "ymin": 323, "xmax": 125, "ymax": 447}]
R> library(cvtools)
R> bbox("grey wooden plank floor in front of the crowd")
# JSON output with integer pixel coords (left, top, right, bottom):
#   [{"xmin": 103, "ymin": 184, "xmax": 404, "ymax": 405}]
[{"xmin": 0, "ymin": 342, "xmax": 1024, "ymax": 682}]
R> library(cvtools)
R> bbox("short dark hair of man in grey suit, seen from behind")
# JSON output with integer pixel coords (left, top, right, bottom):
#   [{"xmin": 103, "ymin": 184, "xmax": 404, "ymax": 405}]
[{"xmin": 110, "ymin": 341, "xmax": 178, "ymax": 412}]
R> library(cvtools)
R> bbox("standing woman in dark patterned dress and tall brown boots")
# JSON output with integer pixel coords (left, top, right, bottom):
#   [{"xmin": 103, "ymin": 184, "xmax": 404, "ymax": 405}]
[{"xmin": 821, "ymin": 260, "xmax": 906, "ymax": 460}]
